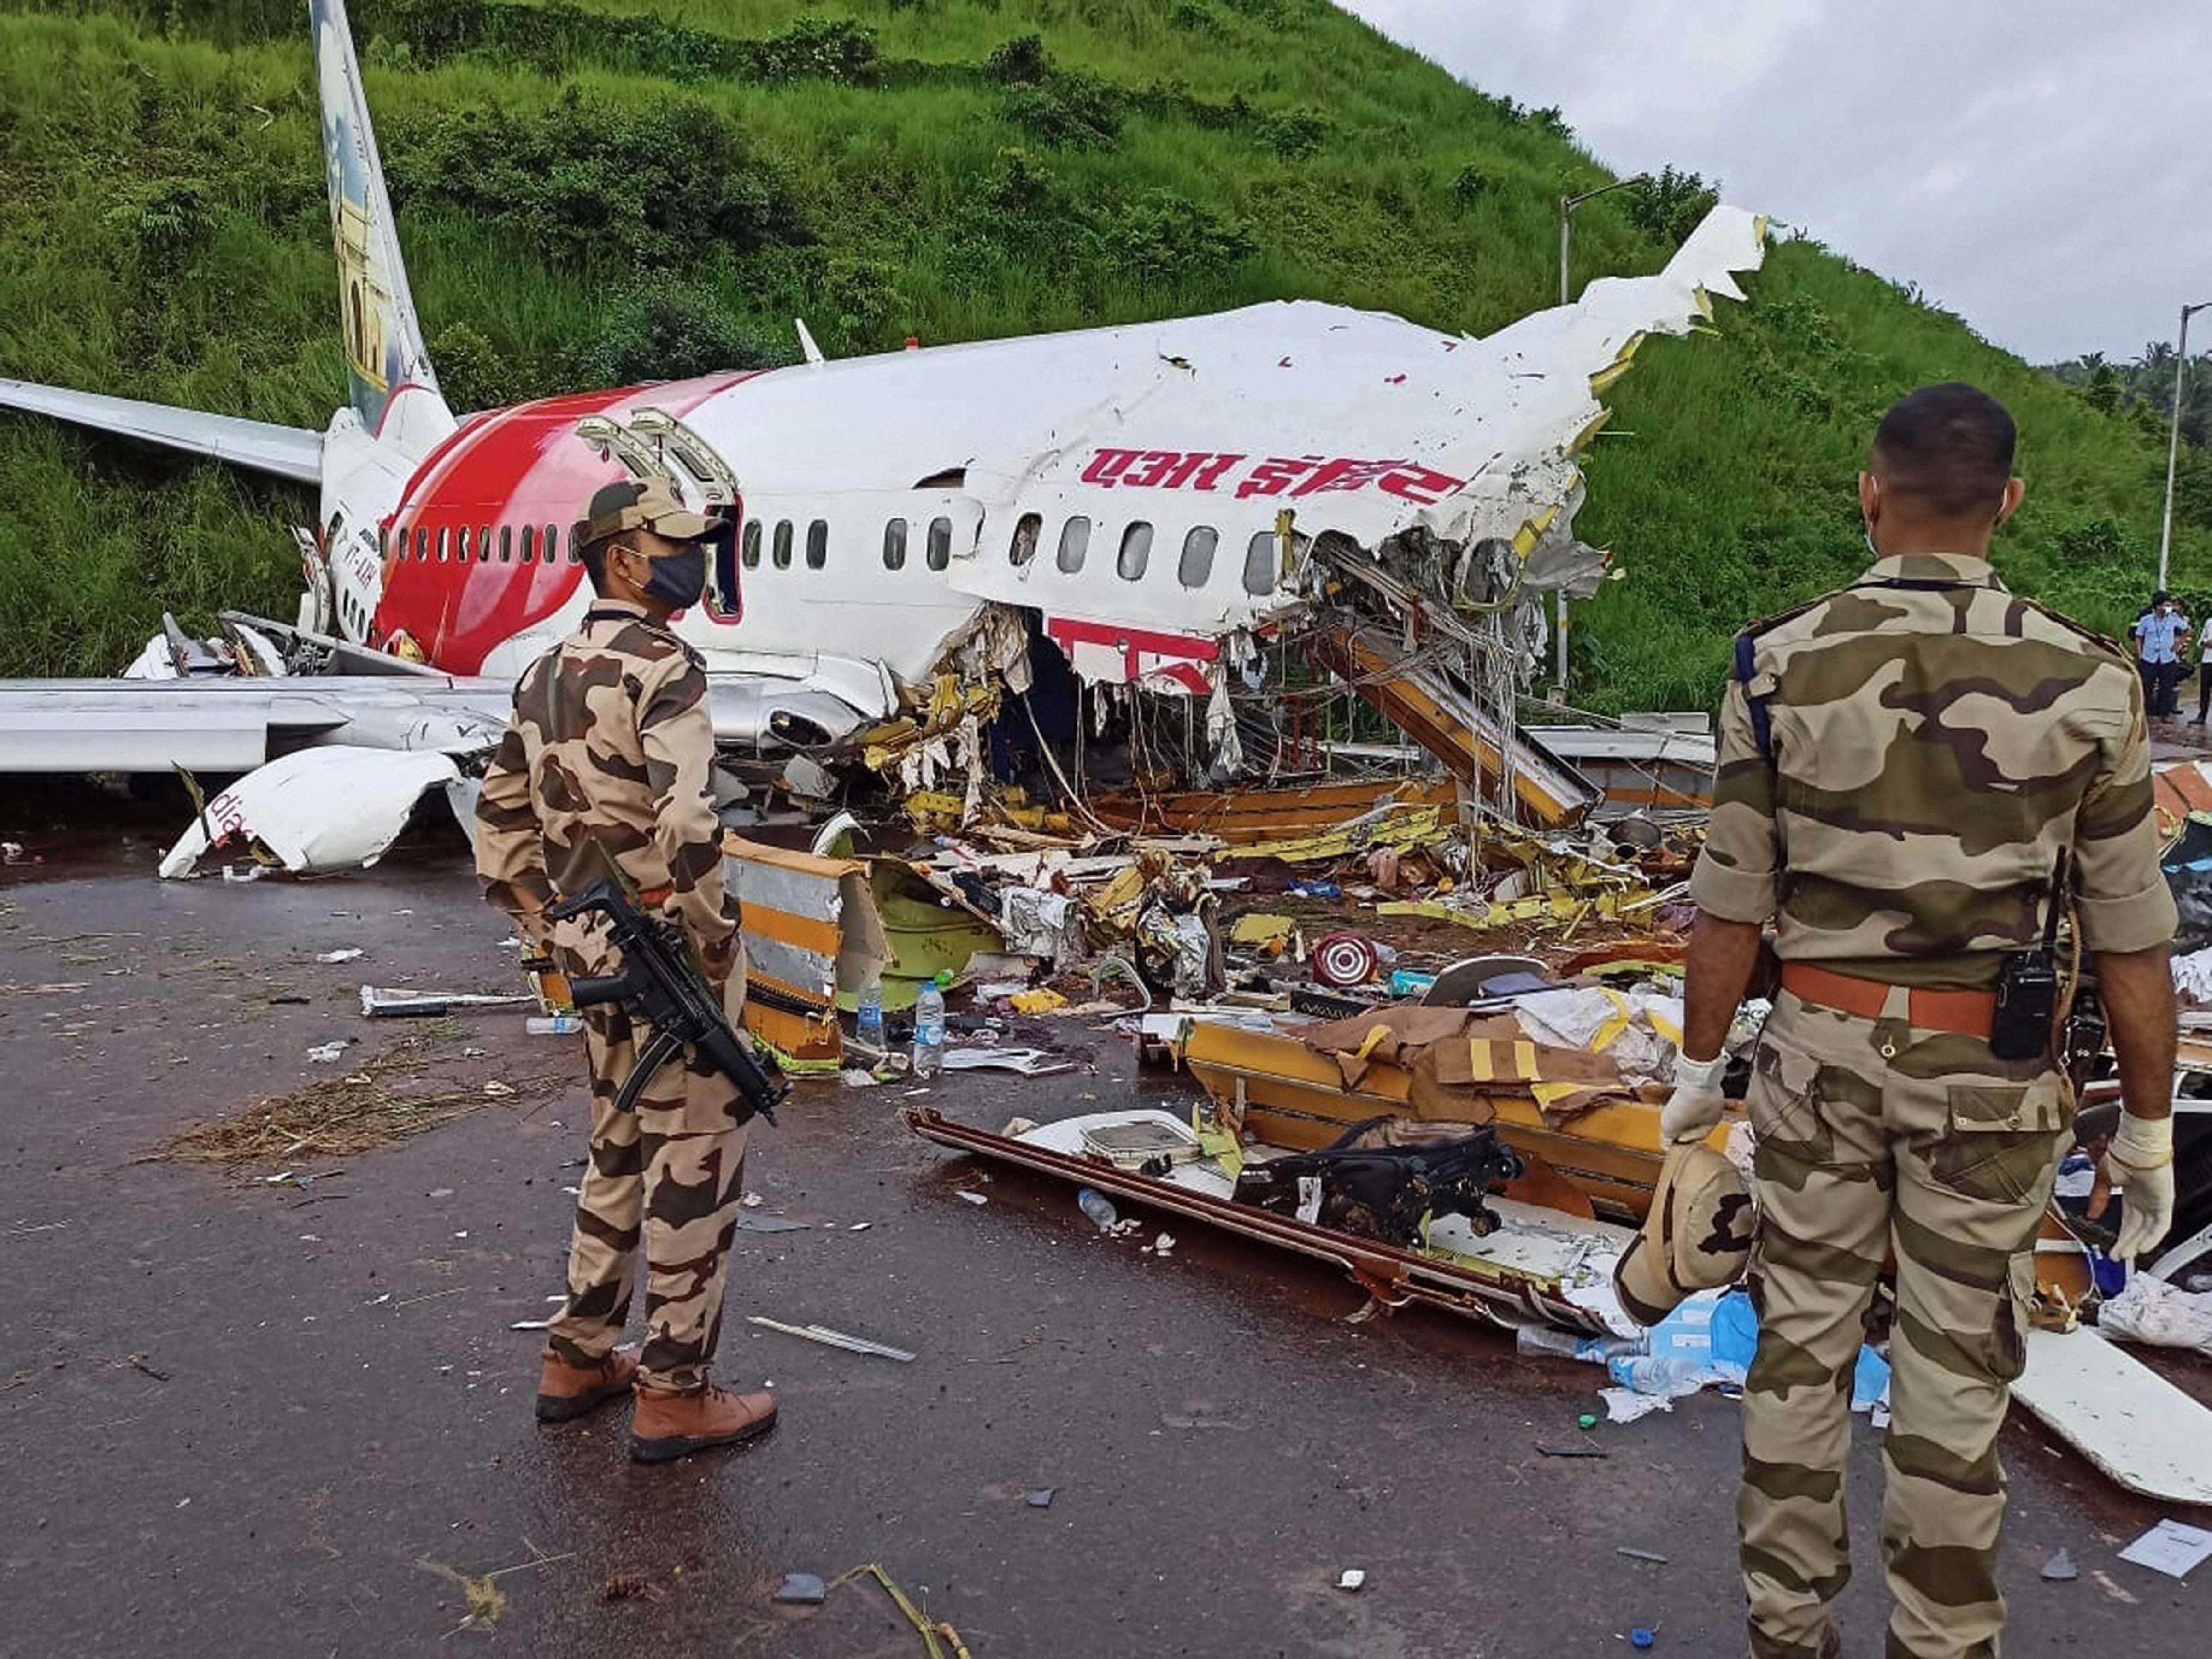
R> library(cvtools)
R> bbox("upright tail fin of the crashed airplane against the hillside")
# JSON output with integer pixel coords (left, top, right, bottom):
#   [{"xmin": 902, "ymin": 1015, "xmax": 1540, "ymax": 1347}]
[{"xmin": 307, "ymin": 0, "xmax": 451, "ymax": 434}]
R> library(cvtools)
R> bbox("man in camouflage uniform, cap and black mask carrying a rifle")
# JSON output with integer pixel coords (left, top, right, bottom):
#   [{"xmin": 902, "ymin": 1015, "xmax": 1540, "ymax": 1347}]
[{"xmin": 476, "ymin": 482, "xmax": 777, "ymax": 1462}]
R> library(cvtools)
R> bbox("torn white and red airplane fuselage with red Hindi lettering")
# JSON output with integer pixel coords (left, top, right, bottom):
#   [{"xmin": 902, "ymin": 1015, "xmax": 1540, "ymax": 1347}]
[{"xmin": 370, "ymin": 210, "xmax": 1759, "ymax": 694}]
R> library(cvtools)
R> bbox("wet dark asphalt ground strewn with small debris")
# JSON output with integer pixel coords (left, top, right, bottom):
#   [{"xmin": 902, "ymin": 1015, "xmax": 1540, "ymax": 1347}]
[{"xmin": 0, "ymin": 836, "xmax": 2212, "ymax": 1659}]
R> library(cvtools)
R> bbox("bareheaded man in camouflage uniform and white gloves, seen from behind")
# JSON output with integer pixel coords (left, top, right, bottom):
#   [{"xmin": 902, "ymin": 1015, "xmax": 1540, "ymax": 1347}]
[{"xmin": 1664, "ymin": 385, "xmax": 2174, "ymax": 1659}]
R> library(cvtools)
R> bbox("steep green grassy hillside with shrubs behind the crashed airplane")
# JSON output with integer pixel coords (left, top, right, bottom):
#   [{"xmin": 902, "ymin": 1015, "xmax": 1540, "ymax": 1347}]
[{"xmin": 0, "ymin": 0, "xmax": 2212, "ymax": 708}]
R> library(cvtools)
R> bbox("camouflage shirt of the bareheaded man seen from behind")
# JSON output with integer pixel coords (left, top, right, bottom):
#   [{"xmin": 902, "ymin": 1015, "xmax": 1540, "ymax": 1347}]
[{"xmin": 1690, "ymin": 555, "xmax": 2174, "ymax": 989}]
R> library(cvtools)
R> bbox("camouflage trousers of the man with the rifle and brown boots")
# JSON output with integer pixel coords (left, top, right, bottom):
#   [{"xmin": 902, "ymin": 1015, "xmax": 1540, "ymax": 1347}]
[{"xmin": 547, "ymin": 967, "xmax": 747, "ymax": 1391}]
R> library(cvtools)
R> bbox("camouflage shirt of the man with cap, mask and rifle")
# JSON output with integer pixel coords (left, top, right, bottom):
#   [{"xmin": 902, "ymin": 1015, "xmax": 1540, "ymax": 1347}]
[{"xmin": 476, "ymin": 600, "xmax": 736, "ymax": 980}]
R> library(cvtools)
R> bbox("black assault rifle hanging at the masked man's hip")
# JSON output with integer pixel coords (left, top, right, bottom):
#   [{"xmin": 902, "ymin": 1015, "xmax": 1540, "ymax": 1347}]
[{"xmin": 547, "ymin": 880, "xmax": 792, "ymax": 1124}]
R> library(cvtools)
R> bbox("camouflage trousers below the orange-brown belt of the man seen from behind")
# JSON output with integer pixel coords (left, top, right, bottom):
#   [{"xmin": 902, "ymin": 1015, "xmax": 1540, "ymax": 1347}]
[{"xmin": 1736, "ymin": 991, "xmax": 2073, "ymax": 1659}]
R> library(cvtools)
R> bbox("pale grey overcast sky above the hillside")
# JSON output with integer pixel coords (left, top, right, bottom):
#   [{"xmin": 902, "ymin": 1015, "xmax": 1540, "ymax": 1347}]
[{"xmin": 1345, "ymin": 0, "xmax": 2212, "ymax": 363}]
